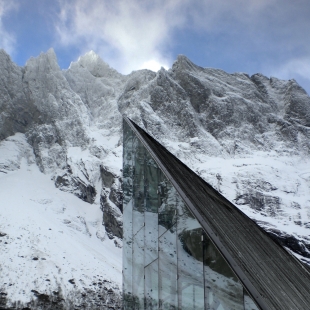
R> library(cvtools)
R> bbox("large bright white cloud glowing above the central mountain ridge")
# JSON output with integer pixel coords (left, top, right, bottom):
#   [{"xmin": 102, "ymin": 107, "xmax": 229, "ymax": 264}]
[{"xmin": 56, "ymin": 0, "xmax": 188, "ymax": 73}]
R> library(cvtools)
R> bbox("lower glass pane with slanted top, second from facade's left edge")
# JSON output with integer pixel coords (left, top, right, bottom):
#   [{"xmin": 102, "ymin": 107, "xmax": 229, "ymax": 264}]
[{"xmin": 132, "ymin": 229, "xmax": 144, "ymax": 309}]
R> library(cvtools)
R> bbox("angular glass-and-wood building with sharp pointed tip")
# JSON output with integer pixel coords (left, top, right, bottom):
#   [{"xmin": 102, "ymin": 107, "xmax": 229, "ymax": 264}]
[{"xmin": 123, "ymin": 117, "xmax": 310, "ymax": 310}]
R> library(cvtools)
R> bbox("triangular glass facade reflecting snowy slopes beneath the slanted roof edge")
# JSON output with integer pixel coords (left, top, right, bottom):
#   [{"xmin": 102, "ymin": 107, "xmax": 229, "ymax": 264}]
[{"xmin": 123, "ymin": 121, "xmax": 258, "ymax": 310}]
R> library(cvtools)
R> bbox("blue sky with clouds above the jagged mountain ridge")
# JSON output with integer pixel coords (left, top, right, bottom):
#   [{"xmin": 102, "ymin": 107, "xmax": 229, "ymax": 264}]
[{"xmin": 0, "ymin": 0, "xmax": 310, "ymax": 94}]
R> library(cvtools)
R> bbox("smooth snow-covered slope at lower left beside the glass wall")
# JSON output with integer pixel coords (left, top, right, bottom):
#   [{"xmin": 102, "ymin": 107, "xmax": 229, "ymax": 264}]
[{"xmin": 0, "ymin": 134, "xmax": 122, "ymax": 302}]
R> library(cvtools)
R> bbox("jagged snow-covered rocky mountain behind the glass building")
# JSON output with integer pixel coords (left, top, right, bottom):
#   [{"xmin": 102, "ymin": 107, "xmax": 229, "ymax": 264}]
[{"xmin": 0, "ymin": 50, "xmax": 310, "ymax": 309}]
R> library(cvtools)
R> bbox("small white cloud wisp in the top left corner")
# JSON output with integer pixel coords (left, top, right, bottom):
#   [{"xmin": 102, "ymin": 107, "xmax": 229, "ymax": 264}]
[{"xmin": 0, "ymin": 0, "xmax": 17, "ymax": 55}]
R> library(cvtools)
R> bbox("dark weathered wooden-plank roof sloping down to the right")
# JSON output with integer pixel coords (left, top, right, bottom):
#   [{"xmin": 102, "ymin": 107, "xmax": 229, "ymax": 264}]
[{"xmin": 124, "ymin": 117, "xmax": 310, "ymax": 310}]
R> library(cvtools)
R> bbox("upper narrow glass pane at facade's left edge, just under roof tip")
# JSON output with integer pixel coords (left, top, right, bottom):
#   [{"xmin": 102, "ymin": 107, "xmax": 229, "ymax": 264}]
[{"xmin": 123, "ymin": 121, "xmax": 133, "ymax": 210}]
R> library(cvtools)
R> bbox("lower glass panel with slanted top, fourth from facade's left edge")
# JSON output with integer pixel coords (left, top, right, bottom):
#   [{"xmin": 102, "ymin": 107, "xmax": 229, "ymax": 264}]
[{"xmin": 159, "ymin": 225, "xmax": 177, "ymax": 310}]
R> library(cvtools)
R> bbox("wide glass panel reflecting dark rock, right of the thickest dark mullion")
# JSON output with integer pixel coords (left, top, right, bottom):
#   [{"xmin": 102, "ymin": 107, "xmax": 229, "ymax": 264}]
[{"xmin": 203, "ymin": 234, "xmax": 244, "ymax": 310}]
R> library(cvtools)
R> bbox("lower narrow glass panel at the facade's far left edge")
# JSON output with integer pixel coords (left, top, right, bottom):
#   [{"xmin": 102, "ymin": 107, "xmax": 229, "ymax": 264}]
[{"xmin": 123, "ymin": 203, "xmax": 132, "ymax": 309}]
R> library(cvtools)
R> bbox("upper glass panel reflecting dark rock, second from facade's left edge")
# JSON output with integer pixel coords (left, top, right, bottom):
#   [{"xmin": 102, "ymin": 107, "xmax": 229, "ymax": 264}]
[{"xmin": 133, "ymin": 136, "xmax": 145, "ymax": 235}]
